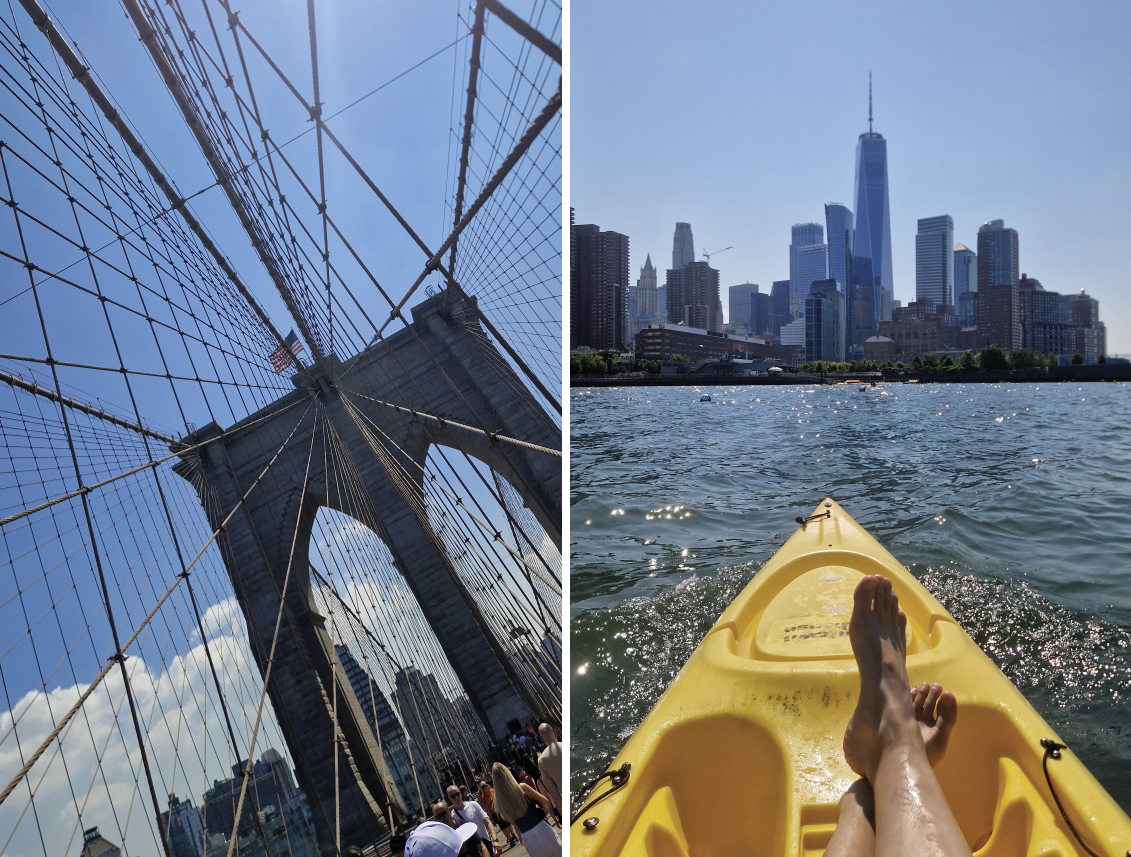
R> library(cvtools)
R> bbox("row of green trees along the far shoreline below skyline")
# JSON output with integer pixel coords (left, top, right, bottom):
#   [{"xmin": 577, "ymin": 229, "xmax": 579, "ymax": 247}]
[{"xmin": 569, "ymin": 345, "xmax": 1107, "ymax": 375}]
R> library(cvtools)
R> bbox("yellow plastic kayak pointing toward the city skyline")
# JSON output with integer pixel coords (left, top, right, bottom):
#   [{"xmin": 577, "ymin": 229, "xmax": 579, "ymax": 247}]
[{"xmin": 570, "ymin": 500, "xmax": 1131, "ymax": 857}]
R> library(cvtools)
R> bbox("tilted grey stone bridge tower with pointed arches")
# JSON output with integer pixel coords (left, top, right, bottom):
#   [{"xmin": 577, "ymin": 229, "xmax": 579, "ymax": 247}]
[{"xmin": 175, "ymin": 292, "xmax": 562, "ymax": 850}]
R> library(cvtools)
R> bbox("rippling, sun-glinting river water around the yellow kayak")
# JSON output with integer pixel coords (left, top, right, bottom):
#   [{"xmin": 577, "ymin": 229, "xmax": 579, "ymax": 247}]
[{"xmin": 570, "ymin": 383, "xmax": 1131, "ymax": 813}]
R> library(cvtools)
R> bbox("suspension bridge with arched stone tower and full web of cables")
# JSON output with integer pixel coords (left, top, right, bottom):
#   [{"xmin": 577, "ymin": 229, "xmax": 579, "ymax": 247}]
[{"xmin": 0, "ymin": 0, "xmax": 563, "ymax": 857}]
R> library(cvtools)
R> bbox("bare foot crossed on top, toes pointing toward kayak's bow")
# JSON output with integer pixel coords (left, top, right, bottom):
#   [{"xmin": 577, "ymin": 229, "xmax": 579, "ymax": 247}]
[{"xmin": 844, "ymin": 574, "xmax": 920, "ymax": 784}]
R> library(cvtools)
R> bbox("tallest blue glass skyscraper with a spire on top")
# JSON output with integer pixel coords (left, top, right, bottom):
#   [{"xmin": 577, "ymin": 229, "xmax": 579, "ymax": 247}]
[{"xmin": 853, "ymin": 75, "xmax": 893, "ymax": 326}]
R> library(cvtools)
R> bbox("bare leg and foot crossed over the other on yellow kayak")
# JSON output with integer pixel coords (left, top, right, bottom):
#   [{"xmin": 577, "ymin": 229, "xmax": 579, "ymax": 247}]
[{"xmin": 844, "ymin": 575, "xmax": 970, "ymax": 857}]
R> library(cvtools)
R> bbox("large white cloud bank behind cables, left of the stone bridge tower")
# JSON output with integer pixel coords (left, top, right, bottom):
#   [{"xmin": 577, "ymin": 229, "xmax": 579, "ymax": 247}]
[{"xmin": 0, "ymin": 599, "xmax": 286, "ymax": 857}]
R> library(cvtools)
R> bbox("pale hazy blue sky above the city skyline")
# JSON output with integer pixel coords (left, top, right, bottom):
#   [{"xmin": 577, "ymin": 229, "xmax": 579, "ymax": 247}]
[{"xmin": 570, "ymin": 0, "xmax": 1131, "ymax": 354}]
